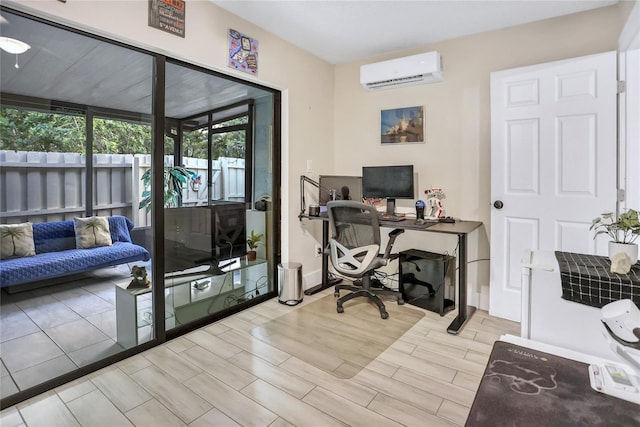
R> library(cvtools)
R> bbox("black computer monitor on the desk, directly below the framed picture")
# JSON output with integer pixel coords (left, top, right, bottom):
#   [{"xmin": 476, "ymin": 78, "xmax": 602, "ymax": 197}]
[{"xmin": 362, "ymin": 165, "xmax": 415, "ymax": 215}]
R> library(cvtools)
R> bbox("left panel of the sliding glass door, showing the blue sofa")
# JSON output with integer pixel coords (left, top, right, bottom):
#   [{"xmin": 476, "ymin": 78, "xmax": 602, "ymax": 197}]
[{"xmin": 0, "ymin": 9, "xmax": 155, "ymax": 402}]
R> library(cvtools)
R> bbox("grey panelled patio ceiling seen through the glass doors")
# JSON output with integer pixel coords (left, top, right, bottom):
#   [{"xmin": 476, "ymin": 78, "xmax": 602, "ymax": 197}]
[{"xmin": 0, "ymin": 11, "xmax": 269, "ymax": 119}]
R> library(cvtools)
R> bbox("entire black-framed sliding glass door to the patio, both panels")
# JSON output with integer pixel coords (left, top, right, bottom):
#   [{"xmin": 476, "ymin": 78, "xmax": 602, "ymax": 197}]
[{"xmin": 0, "ymin": 7, "xmax": 279, "ymax": 407}]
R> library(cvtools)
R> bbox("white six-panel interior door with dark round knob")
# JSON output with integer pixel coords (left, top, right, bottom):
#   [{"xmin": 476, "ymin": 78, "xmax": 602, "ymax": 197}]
[{"xmin": 489, "ymin": 52, "xmax": 617, "ymax": 321}]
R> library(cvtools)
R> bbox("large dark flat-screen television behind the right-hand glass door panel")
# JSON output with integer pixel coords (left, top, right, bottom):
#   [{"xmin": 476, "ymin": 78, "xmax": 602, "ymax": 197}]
[{"xmin": 164, "ymin": 201, "xmax": 247, "ymax": 275}]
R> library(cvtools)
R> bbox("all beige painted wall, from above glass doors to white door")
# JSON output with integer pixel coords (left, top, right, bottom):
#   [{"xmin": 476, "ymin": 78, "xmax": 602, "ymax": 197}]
[{"xmin": 4, "ymin": 0, "xmax": 631, "ymax": 308}]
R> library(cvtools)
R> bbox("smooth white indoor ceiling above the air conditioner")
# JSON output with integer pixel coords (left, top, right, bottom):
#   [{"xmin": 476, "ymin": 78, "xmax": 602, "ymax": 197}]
[{"xmin": 210, "ymin": 0, "xmax": 618, "ymax": 64}]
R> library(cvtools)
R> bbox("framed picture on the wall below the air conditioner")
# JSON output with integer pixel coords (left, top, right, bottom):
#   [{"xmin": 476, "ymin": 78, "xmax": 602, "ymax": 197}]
[{"xmin": 380, "ymin": 106, "xmax": 424, "ymax": 144}]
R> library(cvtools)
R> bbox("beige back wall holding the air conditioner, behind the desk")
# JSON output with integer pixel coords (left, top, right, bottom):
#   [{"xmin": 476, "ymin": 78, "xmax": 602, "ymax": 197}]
[{"xmin": 334, "ymin": 4, "xmax": 630, "ymax": 308}]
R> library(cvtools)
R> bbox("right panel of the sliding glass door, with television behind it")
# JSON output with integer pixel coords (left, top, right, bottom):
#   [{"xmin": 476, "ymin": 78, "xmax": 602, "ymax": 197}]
[{"xmin": 164, "ymin": 62, "xmax": 274, "ymax": 331}]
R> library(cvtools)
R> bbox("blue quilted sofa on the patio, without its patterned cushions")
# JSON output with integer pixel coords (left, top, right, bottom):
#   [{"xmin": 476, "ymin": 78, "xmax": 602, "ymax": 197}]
[{"xmin": 0, "ymin": 216, "xmax": 150, "ymax": 288}]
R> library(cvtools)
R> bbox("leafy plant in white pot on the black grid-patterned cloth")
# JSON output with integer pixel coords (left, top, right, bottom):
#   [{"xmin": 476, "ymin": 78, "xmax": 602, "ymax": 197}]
[{"xmin": 589, "ymin": 209, "xmax": 640, "ymax": 264}]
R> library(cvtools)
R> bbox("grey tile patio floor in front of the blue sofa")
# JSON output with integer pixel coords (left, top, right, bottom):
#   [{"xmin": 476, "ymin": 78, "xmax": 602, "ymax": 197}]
[{"xmin": 0, "ymin": 265, "xmax": 140, "ymax": 397}]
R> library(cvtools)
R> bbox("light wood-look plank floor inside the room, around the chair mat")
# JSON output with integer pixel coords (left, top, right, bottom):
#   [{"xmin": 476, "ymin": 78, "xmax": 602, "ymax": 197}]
[{"xmin": 0, "ymin": 289, "xmax": 519, "ymax": 427}]
